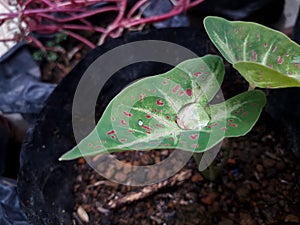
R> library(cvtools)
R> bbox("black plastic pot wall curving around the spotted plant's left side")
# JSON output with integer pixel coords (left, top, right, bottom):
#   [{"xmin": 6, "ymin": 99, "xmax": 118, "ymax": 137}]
[{"xmin": 18, "ymin": 28, "xmax": 216, "ymax": 225}]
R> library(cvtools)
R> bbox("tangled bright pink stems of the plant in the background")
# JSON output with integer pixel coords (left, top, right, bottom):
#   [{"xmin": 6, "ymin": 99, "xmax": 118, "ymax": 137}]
[{"xmin": 0, "ymin": 0, "xmax": 204, "ymax": 51}]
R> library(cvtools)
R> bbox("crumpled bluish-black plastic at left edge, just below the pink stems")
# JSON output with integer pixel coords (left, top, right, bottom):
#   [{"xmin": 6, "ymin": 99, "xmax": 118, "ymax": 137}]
[{"xmin": 0, "ymin": 43, "xmax": 56, "ymax": 114}]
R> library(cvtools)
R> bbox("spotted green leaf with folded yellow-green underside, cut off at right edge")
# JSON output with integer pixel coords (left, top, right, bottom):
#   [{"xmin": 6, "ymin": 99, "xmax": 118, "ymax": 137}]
[{"xmin": 204, "ymin": 16, "xmax": 300, "ymax": 88}]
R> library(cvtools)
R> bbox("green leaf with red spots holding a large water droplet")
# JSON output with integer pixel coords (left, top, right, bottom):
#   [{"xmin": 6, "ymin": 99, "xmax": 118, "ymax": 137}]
[{"xmin": 60, "ymin": 55, "xmax": 266, "ymax": 160}]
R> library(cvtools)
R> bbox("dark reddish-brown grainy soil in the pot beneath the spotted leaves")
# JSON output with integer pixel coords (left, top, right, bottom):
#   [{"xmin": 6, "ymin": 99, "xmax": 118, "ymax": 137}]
[{"xmin": 73, "ymin": 114, "xmax": 300, "ymax": 225}]
